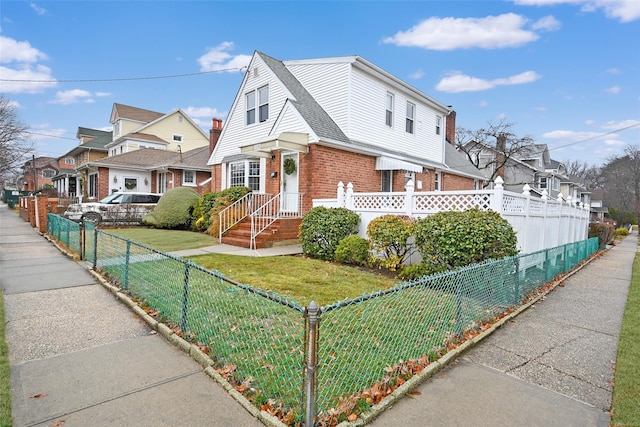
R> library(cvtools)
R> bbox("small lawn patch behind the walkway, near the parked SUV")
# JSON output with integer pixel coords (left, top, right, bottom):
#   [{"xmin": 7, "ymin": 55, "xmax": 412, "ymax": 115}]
[{"xmin": 104, "ymin": 227, "xmax": 218, "ymax": 252}]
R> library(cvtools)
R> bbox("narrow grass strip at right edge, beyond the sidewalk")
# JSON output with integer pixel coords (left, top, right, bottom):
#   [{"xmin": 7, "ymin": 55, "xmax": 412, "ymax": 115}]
[{"xmin": 611, "ymin": 256, "xmax": 640, "ymax": 426}]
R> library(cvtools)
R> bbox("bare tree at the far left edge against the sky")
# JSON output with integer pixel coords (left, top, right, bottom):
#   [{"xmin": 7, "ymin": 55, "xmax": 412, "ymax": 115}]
[{"xmin": 0, "ymin": 94, "xmax": 34, "ymax": 184}]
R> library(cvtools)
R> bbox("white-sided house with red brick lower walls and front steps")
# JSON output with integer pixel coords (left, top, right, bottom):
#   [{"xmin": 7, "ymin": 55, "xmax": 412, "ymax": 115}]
[{"xmin": 209, "ymin": 52, "xmax": 484, "ymax": 213}]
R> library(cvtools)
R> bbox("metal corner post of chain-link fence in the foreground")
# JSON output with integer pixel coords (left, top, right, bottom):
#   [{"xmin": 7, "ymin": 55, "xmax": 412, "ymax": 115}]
[{"xmin": 304, "ymin": 301, "xmax": 322, "ymax": 427}]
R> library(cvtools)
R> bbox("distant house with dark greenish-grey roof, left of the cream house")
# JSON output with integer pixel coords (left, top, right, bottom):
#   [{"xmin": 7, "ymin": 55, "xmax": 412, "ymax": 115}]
[{"xmin": 52, "ymin": 127, "xmax": 112, "ymax": 197}]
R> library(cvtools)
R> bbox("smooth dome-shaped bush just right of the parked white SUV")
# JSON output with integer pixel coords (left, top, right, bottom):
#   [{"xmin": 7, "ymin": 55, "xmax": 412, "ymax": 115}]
[{"xmin": 142, "ymin": 187, "xmax": 200, "ymax": 229}]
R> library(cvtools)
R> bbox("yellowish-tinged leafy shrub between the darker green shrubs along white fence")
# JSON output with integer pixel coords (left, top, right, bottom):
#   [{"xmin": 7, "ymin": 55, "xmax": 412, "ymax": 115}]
[{"xmin": 367, "ymin": 215, "xmax": 416, "ymax": 271}]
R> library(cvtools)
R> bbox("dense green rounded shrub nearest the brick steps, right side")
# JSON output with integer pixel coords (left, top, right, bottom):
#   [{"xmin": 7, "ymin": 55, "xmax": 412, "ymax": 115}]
[{"xmin": 298, "ymin": 206, "xmax": 360, "ymax": 261}]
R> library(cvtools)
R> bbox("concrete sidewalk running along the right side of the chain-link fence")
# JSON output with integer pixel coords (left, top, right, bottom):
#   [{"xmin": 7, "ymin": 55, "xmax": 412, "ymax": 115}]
[{"xmin": 371, "ymin": 235, "xmax": 638, "ymax": 427}]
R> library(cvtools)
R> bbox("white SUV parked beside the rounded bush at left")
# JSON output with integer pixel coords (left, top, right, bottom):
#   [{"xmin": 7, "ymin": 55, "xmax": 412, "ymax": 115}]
[{"xmin": 63, "ymin": 192, "xmax": 162, "ymax": 223}]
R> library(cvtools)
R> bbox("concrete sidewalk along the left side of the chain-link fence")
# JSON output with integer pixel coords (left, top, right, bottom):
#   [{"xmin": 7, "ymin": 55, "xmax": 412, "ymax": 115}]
[{"xmin": 0, "ymin": 203, "xmax": 263, "ymax": 427}]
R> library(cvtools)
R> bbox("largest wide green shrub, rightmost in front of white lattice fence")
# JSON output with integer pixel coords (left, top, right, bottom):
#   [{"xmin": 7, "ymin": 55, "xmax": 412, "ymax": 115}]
[{"xmin": 415, "ymin": 209, "xmax": 518, "ymax": 271}]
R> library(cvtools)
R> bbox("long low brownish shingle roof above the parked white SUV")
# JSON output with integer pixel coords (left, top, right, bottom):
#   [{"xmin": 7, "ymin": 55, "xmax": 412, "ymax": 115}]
[{"xmin": 90, "ymin": 147, "xmax": 211, "ymax": 171}]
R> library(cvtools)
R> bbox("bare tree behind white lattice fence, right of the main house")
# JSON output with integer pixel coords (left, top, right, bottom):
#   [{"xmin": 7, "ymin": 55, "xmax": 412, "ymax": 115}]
[{"xmin": 456, "ymin": 119, "xmax": 534, "ymax": 184}]
